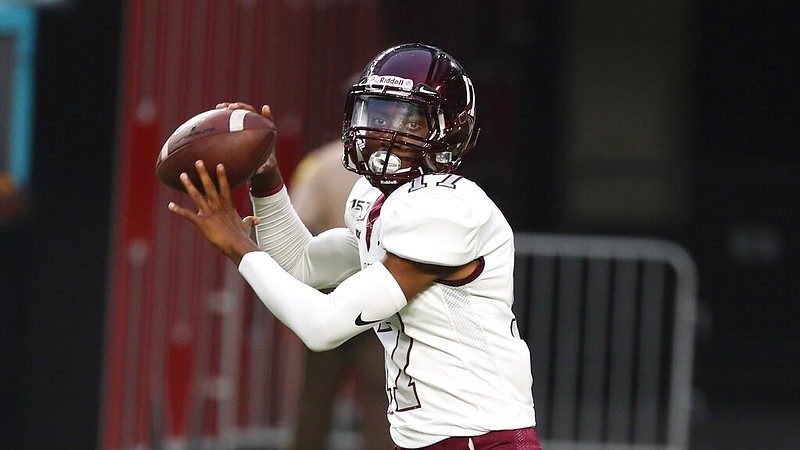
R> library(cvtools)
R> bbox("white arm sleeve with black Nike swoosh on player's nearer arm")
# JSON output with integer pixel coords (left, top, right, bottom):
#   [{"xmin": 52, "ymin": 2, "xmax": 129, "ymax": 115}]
[{"xmin": 239, "ymin": 252, "xmax": 406, "ymax": 351}]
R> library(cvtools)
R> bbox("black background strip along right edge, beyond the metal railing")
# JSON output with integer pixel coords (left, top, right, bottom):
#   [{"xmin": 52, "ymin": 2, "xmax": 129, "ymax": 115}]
[{"xmin": 686, "ymin": 0, "xmax": 800, "ymax": 449}]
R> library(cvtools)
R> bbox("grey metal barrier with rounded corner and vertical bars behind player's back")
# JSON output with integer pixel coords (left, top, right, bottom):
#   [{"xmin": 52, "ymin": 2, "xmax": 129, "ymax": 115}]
[{"xmin": 515, "ymin": 234, "xmax": 697, "ymax": 450}]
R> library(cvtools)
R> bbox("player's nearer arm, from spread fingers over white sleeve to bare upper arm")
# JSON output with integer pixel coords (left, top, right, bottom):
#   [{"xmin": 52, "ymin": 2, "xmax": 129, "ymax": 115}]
[{"xmin": 169, "ymin": 161, "xmax": 468, "ymax": 351}]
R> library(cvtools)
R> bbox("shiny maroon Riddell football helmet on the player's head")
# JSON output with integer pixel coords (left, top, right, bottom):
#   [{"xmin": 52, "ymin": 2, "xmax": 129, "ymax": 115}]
[{"xmin": 342, "ymin": 44, "xmax": 479, "ymax": 192}]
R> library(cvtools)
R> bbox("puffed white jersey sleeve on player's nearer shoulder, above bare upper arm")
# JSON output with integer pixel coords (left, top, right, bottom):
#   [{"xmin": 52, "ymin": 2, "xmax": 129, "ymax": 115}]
[{"xmin": 381, "ymin": 180, "xmax": 489, "ymax": 266}]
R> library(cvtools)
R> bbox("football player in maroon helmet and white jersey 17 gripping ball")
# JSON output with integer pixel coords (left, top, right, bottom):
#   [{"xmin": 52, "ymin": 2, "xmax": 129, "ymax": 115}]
[{"xmin": 169, "ymin": 44, "xmax": 540, "ymax": 450}]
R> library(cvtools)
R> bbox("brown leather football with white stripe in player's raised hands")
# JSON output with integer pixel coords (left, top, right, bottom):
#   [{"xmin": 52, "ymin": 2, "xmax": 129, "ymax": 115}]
[{"xmin": 156, "ymin": 108, "xmax": 278, "ymax": 192}]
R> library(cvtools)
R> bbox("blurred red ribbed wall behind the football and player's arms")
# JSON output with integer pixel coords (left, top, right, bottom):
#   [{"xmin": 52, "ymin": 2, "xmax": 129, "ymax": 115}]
[{"xmin": 100, "ymin": 0, "xmax": 384, "ymax": 449}]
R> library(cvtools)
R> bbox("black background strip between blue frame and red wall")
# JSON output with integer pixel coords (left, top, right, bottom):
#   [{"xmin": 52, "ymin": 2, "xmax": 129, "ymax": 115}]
[{"xmin": 0, "ymin": 0, "xmax": 121, "ymax": 450}]
